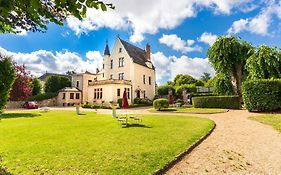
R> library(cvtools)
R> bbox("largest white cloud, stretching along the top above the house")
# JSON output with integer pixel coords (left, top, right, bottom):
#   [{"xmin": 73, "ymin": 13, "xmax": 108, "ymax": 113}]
[{"xmin": 67, "ymin": 0, "xmax": 253, "ymax": 42}]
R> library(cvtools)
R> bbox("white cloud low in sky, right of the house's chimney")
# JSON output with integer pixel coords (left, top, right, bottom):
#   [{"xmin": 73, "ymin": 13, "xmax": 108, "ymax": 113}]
[{"xmin": 151, "ymin": 52, "xmax": 215, "ymax": 84}]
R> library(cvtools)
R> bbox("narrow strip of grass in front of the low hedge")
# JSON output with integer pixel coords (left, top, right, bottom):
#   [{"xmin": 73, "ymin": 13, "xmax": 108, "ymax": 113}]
[{"xmin": 149, "ymin": 107, "xmax": 228, "ymax": 114}]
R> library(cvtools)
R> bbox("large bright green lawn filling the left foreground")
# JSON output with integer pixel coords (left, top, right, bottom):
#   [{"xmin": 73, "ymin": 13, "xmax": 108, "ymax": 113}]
[{"xmin": 0, "ymin": 111, "xmax": 214, "ymax": 174}]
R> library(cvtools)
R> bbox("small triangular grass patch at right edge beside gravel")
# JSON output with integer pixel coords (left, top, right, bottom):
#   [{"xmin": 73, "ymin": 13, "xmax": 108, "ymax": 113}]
[{"xmin": 250, "ymin": 114, "xmax": 281, "ymax": 132}]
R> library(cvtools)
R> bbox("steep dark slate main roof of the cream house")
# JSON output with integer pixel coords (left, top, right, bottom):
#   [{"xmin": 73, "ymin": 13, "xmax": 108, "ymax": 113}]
[{"xmin": 119, "ymin": 38, "xmax": 155, "ymax": 69}]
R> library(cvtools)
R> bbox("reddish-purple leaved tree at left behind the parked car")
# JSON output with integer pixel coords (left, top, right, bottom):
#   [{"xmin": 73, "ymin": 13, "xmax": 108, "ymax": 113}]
[{"xmin": 10, "ymin": 62, "xmax": 32, "ymax": 101}]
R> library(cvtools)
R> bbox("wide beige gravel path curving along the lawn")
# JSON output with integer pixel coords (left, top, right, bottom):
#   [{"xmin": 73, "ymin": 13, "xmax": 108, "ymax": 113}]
[{"xmin": 166, "ymin": 110, "xmax": 281, "ymax": 175}]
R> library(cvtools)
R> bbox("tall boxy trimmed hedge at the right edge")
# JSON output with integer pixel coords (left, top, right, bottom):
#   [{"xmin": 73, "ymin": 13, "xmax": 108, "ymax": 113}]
[{"xmin": 242, "ymin": 79, "xmax": 281, "ymax": 112}]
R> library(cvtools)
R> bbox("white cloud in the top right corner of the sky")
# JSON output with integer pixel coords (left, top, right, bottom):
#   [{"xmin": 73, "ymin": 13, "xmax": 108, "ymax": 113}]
[{"xmin": 228, "ymin": 1, "xmax": 281, "ymax": 35}]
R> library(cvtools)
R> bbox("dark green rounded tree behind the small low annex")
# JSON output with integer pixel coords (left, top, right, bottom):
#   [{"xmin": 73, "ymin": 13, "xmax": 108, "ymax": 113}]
[{"xmin": 45, "ymin": 75, "xmax": 71, "ymax": 93}]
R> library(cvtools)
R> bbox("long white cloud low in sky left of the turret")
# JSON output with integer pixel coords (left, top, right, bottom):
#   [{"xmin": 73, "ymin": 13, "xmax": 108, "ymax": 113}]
[{"xmin": 0, "ymin": 47, "xmax": 102, "ymax": 76}]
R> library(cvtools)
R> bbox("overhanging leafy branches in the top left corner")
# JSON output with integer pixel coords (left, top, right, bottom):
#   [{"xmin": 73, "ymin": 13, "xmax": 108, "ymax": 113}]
[{"xmin": 0, "ymin": 0, "xmax": 115, "ymax": 33}]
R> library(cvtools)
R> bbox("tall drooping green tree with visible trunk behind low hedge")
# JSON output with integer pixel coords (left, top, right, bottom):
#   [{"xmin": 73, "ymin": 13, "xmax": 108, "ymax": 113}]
[{"xmin": 207, "ymin": 36, "xmax": 253, "ymax": 100}]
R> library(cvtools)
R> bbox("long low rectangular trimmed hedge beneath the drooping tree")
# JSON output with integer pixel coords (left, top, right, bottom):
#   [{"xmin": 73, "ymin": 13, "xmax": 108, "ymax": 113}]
[{"xmin": 192, "ymin": 96, "xmax": 240, "ymax": 109}]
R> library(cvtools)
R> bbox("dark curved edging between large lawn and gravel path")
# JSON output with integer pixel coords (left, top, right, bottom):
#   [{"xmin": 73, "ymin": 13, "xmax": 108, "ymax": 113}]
[{"xmin": 153, "ymin": 123, "xmax": 216, "ymax": 175}]
